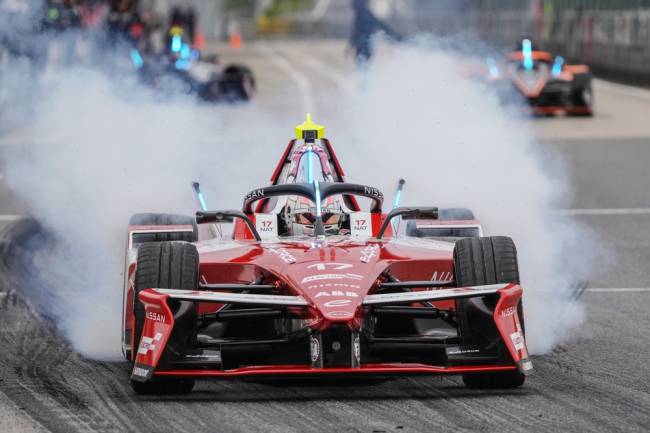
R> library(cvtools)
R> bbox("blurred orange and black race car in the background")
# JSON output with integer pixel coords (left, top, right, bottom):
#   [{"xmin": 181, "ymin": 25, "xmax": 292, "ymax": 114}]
[{"xmin": 487, "ymin": 39, "xmax": 593, "ymax": 116}]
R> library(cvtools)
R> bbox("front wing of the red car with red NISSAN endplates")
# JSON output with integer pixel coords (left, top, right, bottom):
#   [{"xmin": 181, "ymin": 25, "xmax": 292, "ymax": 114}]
[{"xmin": 131, "ymin": 284, "xmax": 532, "ymax": 382}]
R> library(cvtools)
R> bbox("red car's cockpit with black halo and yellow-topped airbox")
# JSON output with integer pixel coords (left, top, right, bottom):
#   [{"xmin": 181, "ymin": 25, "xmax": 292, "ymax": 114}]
[{"xmin": 195, "ymin": 115, "xmax": 390, "ymax": 239}]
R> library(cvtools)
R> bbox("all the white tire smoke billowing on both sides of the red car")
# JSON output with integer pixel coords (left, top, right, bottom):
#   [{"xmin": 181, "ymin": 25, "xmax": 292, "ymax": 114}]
[{"xmin": 1, "ymin": 34, "xmax": 589, "ymax": 359}]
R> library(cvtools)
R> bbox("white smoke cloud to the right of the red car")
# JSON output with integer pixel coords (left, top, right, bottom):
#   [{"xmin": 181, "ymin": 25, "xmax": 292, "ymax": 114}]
[{"xmin": 335, "ymin": 43, "xmax": 597, "ymax": 353}]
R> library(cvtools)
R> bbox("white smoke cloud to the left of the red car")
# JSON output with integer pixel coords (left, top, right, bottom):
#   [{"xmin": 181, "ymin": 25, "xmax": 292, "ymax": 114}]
[{"xmin": 1, "ymin": 64, "xmax": 280, "ymax": 359}]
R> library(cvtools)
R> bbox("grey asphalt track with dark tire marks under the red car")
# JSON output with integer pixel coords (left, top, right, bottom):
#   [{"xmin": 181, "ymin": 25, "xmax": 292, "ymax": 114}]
[{"xmin": 0, "ymin": 42, "xmax": 650, "ymax": 432}]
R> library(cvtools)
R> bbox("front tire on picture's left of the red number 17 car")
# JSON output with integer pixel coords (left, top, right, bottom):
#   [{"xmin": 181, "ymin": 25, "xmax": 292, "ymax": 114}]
[{"xmin": 131, "ymin": 242, "xmax": 199, "ymax": 394}]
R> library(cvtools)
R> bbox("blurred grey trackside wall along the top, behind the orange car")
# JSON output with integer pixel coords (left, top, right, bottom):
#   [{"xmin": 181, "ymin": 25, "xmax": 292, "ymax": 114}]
[{"xmin": 234, "ymin": 0, "xmax": 650, "ymax": 85}]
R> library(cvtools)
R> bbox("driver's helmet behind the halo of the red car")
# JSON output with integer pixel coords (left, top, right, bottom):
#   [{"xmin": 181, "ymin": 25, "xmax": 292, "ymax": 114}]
[{"xmin": 283, "ymin": 197, "xmax": 343, "ymax": 236}]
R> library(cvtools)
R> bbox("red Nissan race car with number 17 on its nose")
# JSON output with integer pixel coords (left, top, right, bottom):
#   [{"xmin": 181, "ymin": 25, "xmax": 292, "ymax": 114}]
[{"xmin": 122, "ymin": 114, "xmax": 532, "ymax": 394}]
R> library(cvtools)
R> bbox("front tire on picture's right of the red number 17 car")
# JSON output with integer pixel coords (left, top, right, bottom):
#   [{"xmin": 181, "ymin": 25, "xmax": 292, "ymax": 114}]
[{"xmin": 454, "ymin": 236, "xmax": 526, "ymax": 389}]
